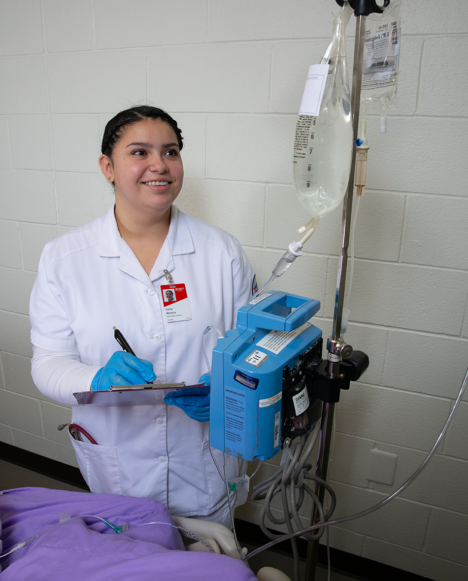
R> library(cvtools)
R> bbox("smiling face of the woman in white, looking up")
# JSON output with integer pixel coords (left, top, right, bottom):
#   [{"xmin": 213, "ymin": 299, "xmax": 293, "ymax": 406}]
[{"xmin": 99, "ymin": 119, "xmax": 184, "ymax": 218}]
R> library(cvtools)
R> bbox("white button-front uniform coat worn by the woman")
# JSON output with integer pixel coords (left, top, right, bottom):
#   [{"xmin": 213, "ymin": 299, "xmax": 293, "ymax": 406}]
[{"xmin": 30, "ymin": 206, "xmax": 254, "ymax": 516}]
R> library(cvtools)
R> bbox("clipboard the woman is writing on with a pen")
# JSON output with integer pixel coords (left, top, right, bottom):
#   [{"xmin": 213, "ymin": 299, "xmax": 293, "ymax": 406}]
[{"xmin": 73, "ymin": 383, "xmax": 205, "ymax": 407}]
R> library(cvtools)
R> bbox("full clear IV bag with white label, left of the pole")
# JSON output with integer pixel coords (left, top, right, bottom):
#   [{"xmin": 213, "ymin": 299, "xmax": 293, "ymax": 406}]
[{"xmin": 293, "ymin": 3, "xmax": 353, "ymax": 218}]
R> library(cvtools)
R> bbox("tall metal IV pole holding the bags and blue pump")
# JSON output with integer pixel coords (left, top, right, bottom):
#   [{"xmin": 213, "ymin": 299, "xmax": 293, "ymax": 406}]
[{"xmin": 304, "ymin": 0, "xmax": 390, "ymax": 581}]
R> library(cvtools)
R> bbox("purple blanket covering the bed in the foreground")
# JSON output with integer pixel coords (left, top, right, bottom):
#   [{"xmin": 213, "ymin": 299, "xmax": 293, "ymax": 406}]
[{"xmin": 0, "ymin": 488, "xmax": 256, "ymax": 581}]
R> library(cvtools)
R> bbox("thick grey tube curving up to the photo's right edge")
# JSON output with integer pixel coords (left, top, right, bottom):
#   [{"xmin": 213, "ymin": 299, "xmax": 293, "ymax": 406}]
[{"xmin": 244, "ymin": 362, "xmax": 468, "ymax": 561}]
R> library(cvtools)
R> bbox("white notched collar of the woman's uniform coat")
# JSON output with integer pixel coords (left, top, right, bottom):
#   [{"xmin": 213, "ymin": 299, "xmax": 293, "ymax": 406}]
[{"xmin": 99, "ymin": 205, "xmax": 195, "ymax": 285}]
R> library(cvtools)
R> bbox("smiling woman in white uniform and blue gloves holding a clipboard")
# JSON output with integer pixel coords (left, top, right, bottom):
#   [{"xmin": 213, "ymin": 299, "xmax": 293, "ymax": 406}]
[{"xmin": 30, "ymin": 106, "xmax": 254, "ymax": 526}]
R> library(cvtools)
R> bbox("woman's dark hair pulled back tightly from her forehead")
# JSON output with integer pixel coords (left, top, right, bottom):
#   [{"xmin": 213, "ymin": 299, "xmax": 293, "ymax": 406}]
[{"xmin": 101, "ymin": 105, "xmax": 184, "ymax": 158}]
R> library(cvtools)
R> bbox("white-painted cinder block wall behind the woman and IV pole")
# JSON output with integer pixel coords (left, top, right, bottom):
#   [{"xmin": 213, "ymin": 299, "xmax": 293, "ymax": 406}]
[{"xmin": 0, "ymin": 0, "xmax": 468, "ymax": 581}]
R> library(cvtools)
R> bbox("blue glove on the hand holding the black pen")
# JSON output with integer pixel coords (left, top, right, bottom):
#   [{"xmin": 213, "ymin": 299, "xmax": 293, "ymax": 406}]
[{"xmin": 91, "ymin": 351, "xmax": 156, "ymax": 391}]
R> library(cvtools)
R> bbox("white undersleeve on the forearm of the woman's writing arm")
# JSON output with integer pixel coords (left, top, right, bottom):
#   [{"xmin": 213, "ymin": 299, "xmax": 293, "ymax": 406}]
[{"xmin": 31, "ymin": 346, "xmax": 100, "ymax": 405}]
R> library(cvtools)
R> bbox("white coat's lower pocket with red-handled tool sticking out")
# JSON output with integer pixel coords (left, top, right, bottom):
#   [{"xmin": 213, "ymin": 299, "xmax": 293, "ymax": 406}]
[{"xmin": 70, "ymin": 437, "xmax": 123, "ymax": 494}]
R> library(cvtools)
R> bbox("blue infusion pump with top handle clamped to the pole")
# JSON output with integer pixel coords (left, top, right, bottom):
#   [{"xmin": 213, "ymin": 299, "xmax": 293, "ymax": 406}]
[{"xmin": 210, "ymin": 291, "xmax": 322, "ymax": 461}]
